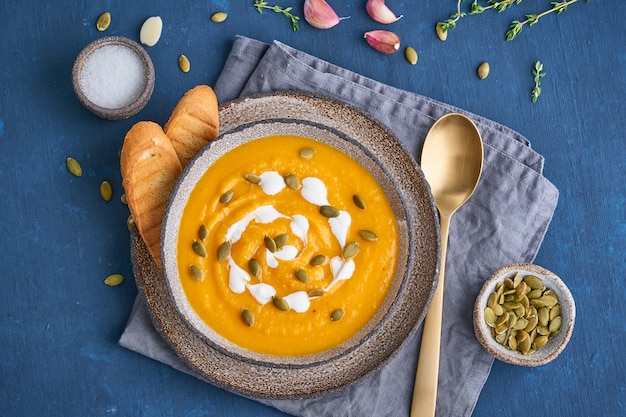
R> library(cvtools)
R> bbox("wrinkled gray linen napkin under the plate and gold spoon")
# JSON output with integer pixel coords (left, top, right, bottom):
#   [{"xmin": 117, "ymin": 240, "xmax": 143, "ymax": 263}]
[{"xmin": 120, "ymin": 37, "xmax": 558, "ymax": 417}]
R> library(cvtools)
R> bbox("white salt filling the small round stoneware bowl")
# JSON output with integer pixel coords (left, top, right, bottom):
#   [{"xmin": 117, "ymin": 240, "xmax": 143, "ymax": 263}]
[{"xmin": 80, "ymin": 45, "xmax": 146, "ymax": 109}]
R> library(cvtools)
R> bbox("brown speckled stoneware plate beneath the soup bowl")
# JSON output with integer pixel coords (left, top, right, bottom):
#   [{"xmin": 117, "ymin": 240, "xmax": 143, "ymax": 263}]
[{"xmin": 131, "ymin": 91, "xmax": 440, "ymax": 399}]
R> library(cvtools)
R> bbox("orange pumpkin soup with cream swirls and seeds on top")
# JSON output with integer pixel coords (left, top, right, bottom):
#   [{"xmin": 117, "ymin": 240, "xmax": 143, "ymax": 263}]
[{"xmin": 177, "ymin": 136, "xmax": 398, "ymax": 356}]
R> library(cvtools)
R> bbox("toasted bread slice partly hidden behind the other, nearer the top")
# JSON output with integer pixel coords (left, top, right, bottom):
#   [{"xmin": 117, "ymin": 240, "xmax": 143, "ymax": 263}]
[{"xmin": 163, "ymin": 85, "xmax": 220, "ymax": 168}]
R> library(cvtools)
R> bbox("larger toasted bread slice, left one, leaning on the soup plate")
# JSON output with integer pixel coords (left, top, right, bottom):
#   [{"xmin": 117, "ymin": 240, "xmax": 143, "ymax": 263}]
[{"xmin": 120, "ymin": 122, "xmax": 182, "ymax": 268}]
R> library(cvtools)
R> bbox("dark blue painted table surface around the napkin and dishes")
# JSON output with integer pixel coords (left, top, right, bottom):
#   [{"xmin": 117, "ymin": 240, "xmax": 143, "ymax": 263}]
[{"xmin": 0, "ymin": 0, "xmax": 626, "ymax": 417}]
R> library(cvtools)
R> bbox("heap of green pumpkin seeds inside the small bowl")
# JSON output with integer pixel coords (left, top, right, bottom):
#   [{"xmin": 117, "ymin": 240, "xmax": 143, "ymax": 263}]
[{"xmin": 483, "ymin": 273, "xmax": 562, "ymax": 355}]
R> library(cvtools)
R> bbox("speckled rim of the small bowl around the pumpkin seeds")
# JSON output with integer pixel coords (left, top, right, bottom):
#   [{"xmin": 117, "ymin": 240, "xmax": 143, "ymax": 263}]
[{"xmin": 473, "ymin": 263, "xmax": 576, "ymax": 366}]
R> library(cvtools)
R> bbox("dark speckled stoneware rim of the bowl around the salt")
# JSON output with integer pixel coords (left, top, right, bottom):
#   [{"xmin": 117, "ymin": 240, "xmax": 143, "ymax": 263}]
[{"xmin": 72, "ymin": 36, "xmax": 155, "ymax": 120}]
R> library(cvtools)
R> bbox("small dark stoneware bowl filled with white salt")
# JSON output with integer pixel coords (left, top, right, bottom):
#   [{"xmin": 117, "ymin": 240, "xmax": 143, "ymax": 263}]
[{"xmin": 72, "ymin": 36, "xmax": 154, "ymax": 120}]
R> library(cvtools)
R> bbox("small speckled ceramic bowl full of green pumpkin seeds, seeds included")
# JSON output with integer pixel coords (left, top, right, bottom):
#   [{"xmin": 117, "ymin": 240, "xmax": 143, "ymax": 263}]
[{"xmin": 473, "ymin": 263, "xmax": 576, "ymax": 366}]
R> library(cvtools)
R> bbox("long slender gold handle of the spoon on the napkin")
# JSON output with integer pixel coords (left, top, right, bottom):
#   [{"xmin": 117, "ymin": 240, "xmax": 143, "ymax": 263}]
[{"xmin": 411, "ymin": 215, "xmax": 450, "ymax": 417}]
